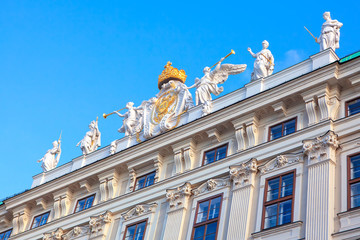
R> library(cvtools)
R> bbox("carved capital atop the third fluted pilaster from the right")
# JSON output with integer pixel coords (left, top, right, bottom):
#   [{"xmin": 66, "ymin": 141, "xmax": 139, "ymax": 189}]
[{"xmin": 166, "ymin": 182, "xmax": 191, "ymax": 209}]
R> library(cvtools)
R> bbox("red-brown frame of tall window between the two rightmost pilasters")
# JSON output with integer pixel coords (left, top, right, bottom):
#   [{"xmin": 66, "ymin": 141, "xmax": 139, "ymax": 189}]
[{"xmin": 261, "ymin": 169, "xmax": 296, "ymax": 230}]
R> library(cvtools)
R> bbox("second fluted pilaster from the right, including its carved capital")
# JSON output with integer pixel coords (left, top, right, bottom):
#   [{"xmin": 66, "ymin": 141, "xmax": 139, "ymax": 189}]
[{"xmin": 227, "ymin": 159, "xmax": 257, "ymax": 240}]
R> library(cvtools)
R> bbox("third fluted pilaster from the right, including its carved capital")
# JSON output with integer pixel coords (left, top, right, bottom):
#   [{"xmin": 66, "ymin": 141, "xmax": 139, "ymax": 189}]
[{"xmin": 163, "ymin": 182, "xmax": 191, "ymax": 240}]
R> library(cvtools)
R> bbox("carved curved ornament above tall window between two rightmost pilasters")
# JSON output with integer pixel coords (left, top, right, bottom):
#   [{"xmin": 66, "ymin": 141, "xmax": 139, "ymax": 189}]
[{"xmin": 258, "ymin": 153, "xmax": 303, "ymax": 175}]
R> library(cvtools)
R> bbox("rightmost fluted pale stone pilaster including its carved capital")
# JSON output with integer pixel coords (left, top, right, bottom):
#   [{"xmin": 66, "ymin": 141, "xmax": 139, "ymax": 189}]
[{"xmin": 303, "ymin": 131, "xmax": 339, "ymax": 240}]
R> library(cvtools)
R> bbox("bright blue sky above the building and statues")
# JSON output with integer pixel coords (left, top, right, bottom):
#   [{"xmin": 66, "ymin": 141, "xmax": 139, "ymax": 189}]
[{"xmin": 0, "ymin": 0, "xmax": 360, "ymax": 199}]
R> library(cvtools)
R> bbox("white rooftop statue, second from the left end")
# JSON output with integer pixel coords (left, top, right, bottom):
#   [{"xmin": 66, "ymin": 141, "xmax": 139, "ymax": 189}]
[{"xmin": 76, "ymin": 118, "xmax": 101, "ymax": 155}]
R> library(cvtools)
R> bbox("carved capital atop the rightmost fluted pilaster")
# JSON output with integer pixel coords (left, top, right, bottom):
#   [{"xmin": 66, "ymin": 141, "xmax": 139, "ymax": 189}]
[{"xmin": 303, "ymin": 131, "xmax": 339, "ymax": 164}]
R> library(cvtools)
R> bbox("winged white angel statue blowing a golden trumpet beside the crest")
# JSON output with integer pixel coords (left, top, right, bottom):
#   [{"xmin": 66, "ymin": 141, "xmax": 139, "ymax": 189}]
[{"xmin": 188, "ymin": 57, "xmax": 246, "ymax": 116}]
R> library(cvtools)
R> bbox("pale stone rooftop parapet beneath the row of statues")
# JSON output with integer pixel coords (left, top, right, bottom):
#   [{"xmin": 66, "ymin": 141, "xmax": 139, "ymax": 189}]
[{"xmin": 31, "ymin": 48, "xmax": 339, "ymax": 188}]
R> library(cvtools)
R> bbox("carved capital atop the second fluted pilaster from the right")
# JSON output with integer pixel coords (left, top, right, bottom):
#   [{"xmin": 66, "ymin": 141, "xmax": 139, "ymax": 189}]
[{"xmin": 229, "ymin": 158, "xmax": 257, "ymax": 188}]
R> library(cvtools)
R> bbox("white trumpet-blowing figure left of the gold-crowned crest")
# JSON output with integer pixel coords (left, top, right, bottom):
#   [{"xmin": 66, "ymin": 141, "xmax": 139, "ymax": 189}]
[{"xmin": 114, "ymin": 102, "xmax": 143, "ymax": 136}]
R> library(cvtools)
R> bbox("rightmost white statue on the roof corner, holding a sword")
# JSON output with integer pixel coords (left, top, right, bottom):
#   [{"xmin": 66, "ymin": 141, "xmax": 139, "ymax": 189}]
[{"xmin": 315, "ymin": 12, "xmax": 343, "ymax": 51}]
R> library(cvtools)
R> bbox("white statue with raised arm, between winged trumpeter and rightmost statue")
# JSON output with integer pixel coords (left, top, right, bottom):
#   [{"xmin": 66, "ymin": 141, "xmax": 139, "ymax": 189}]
[{"xmin": 248, "ymin": 40, "xmax": 275, "ymax": 80}]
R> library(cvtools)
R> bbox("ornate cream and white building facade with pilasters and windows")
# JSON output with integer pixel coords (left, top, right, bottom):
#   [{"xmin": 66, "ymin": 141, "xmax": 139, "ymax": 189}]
[{"xmin": 0, "ymin": 48, "xmax": 360, "ymax": 240}]
